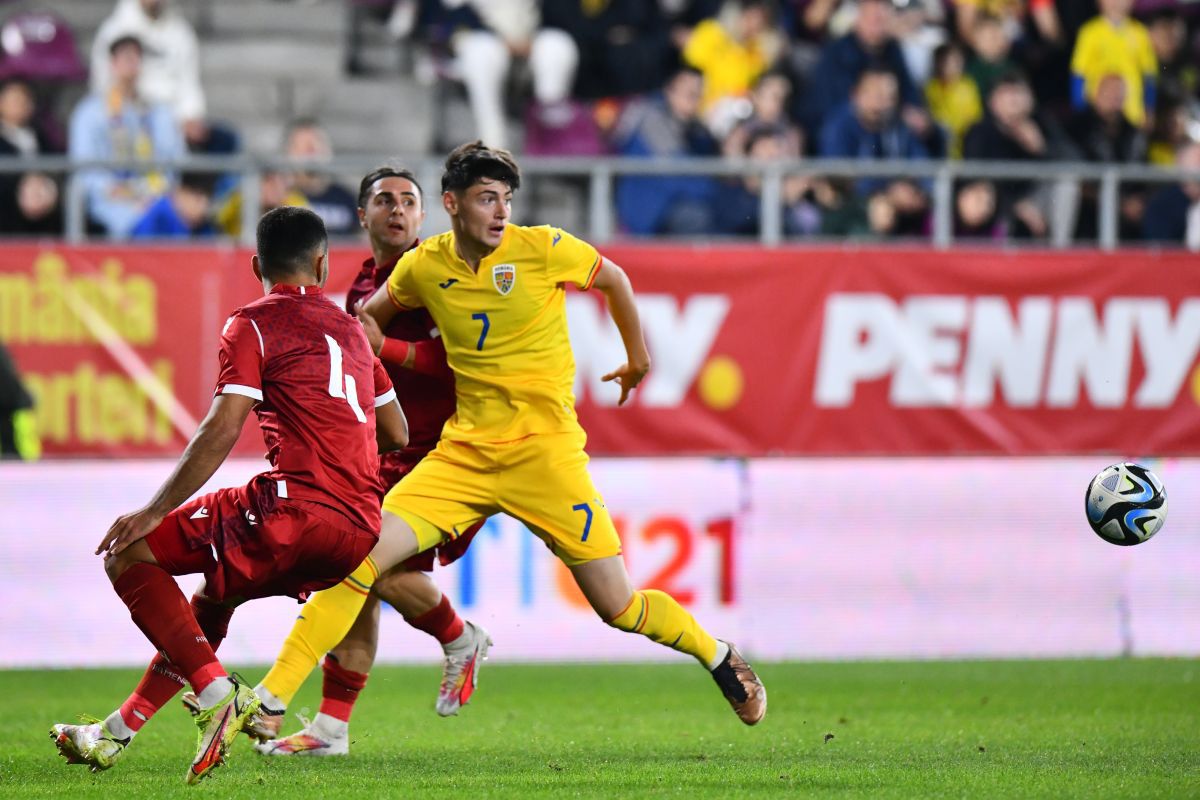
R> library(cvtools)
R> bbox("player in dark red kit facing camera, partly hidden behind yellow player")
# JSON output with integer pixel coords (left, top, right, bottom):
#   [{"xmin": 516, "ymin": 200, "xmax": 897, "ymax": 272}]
[{"xmin": 258, "ymin": 167, "xmax": 491, "ymax": 756}]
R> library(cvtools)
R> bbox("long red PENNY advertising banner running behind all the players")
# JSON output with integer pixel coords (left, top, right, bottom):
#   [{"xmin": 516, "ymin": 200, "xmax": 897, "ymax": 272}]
[{"xmin": 0, "ymin": 246, "xmax": 1200, "ymax": 456}]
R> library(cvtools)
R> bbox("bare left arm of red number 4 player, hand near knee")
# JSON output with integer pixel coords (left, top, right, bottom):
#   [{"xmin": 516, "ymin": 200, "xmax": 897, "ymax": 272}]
[{"xmin": 96, "ymin": 395, "xmax": 256, "ymax": 555}]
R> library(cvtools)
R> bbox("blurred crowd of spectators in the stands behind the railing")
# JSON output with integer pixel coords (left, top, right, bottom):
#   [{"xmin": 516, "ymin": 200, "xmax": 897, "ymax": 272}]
[{"xmin": 0, "ymin": 0, "xmax": 1200, "ymax": 248}]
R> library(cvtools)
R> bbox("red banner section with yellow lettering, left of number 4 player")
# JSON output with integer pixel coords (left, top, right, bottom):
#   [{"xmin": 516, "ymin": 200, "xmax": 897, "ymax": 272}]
[{"xmin": 0, "ymin": 246, "xmax": 319, "ymax": 457}]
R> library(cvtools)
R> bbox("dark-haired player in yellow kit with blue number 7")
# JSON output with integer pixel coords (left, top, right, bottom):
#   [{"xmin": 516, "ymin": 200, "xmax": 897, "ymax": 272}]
[{"xmin": 250, "ymin": 142, "xmax": 767, "ymax": 724}]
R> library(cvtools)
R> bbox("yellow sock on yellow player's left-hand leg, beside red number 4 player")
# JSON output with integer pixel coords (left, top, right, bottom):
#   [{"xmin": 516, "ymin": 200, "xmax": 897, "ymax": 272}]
[{"xmin": 263, "ymin": 555, "xmax": 379, "ymax": 704}]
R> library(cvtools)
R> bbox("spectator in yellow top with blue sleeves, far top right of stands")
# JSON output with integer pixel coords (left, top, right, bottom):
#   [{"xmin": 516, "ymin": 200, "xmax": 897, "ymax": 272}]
[{"xmin": 1070, "ymin": 0, "xmax": 1158, "ymax": 127}]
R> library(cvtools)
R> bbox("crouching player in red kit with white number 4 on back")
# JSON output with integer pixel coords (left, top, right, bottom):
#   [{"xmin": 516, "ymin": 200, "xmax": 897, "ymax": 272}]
[{"xmin": 50, "ymin": 207, "xmax": 408, "ymax": 783}]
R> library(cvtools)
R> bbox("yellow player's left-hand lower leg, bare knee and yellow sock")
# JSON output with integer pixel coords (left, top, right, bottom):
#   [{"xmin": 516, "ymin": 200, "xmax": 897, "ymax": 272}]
[{"xmin": 254, "ymin": 511, "xmax": 421, "ymax": 712}]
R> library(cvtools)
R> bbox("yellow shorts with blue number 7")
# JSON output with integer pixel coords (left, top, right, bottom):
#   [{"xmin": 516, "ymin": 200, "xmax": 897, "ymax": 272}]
[{"xmin": 383, "ymin": 432, "xmax": 620, "ymax": 565}]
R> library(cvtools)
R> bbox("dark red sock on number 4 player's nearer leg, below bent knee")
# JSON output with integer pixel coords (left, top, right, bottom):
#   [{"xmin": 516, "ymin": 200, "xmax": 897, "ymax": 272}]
[{"xmin": 113, "ymin": 564, "xmax": 226, "ymax": 693}]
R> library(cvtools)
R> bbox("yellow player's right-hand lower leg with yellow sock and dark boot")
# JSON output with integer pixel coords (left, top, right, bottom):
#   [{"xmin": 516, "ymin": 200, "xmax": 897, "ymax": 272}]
[{"xmin": 570, "ymin": 555, "xmax": 767, "ymax": 724}]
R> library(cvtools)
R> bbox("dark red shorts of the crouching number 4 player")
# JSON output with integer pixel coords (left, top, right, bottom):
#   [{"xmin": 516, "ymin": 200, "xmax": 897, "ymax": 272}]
[{"xmin": 146, "ymin": 479, "xmax": 378, "ymax": 602}]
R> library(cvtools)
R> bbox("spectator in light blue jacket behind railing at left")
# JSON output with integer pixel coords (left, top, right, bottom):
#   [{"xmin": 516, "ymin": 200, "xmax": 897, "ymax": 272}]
[{"xmin": 68, "ymin": 36, "xmax": 185, "ymax": 239}]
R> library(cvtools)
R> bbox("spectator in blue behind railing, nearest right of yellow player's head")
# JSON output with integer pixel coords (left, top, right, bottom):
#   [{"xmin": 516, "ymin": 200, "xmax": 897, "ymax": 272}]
[{"xmin": 616, "ymin": 67, "xmax": 719, "ymax": 234}]
